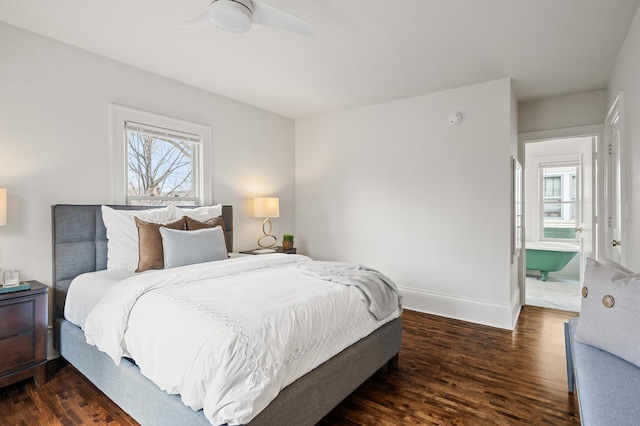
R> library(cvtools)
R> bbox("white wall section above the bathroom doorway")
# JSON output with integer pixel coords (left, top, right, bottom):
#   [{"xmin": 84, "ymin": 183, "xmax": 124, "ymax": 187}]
[{"xmin": 518, "ymin": 90, "xmax": 607, "ymax": 133}]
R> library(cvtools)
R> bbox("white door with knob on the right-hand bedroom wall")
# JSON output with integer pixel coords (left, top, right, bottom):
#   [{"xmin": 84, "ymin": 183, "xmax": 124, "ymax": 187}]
[{"xmin": 603, "ymin": 96, "xmax": 624, "ymax": 265}]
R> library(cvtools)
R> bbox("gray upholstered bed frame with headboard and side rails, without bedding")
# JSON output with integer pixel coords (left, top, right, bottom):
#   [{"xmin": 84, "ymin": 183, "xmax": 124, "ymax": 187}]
[{"xmin": 52, "ymin": 205, "xmax": 402, "ymax": 425}]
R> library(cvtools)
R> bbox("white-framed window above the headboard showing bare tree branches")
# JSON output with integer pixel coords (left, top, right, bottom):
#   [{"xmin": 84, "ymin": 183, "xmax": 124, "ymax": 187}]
[{"xmin": 111, "ymin": 105, "xmax": 211, "ymax": 205}]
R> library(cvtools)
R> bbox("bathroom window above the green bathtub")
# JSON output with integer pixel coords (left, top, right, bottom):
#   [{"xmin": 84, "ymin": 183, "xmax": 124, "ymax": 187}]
[{"xmin": 540, "ymin": 163, "xmax": 578, "ymax": 241}]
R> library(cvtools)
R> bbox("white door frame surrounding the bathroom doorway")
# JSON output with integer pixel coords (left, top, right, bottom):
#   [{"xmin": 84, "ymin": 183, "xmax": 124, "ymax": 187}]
[{"xmin": 518, "ymin": 124, "xmax": 604, "ymax": 306}]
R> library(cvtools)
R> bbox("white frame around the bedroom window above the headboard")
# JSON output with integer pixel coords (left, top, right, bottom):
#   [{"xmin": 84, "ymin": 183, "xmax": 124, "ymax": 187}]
[{"xmin": 109, "ymin": 104, "xmax": 213, "ymax": 205}]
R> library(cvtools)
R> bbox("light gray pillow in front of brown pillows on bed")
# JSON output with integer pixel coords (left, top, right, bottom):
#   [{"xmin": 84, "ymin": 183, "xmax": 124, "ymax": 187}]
[{"xmin": 160, "ymin": 226, "xmax": 228, "ymax": 268}]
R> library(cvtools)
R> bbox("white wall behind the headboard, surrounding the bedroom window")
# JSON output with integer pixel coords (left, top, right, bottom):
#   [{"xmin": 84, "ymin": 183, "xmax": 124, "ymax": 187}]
[{"xmin": 0, "ymin": 23, "xmax": 294, "ymax": 322}]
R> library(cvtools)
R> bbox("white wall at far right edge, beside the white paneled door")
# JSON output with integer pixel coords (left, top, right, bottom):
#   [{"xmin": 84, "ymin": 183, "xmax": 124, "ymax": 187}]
[{"xmin": 607, "ymin": 5, "xmax": 640, "ymax": 272}]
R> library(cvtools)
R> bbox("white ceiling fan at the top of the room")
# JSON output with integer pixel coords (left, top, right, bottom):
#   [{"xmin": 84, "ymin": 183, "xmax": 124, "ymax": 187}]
[{"xmin": 181, "ymin": 0, "xmax": 317, "ymax": 37}]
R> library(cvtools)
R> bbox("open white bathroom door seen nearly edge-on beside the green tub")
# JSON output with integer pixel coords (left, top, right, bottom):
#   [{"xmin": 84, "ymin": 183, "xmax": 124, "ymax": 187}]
[{"xmin": 576, "ymin": 136, "xmax": 597, "ymax": 282}]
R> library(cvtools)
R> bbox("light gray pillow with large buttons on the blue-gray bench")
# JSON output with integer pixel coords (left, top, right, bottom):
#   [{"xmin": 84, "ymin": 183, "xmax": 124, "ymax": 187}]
[{"xmin": 576, "ymin": 259, "xmax": 640, "ymax": 367}]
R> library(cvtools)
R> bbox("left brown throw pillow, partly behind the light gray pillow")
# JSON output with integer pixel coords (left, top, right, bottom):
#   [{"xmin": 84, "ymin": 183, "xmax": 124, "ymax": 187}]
[{"xmin": 134, "ymin": 216, "xmax": 186, "ymax": 272}]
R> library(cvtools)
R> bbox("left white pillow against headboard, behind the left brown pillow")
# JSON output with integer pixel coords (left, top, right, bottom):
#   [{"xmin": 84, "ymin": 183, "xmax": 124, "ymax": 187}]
[{"xmin": 102, "ymin": 206, "xmax": 174, "ymax": 272}]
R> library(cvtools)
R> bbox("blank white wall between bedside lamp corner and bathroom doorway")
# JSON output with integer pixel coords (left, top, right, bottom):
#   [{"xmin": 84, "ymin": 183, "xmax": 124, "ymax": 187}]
[{"xmin": 295, "ymin": 79, "xmax": 519, "ymax": 328}]
